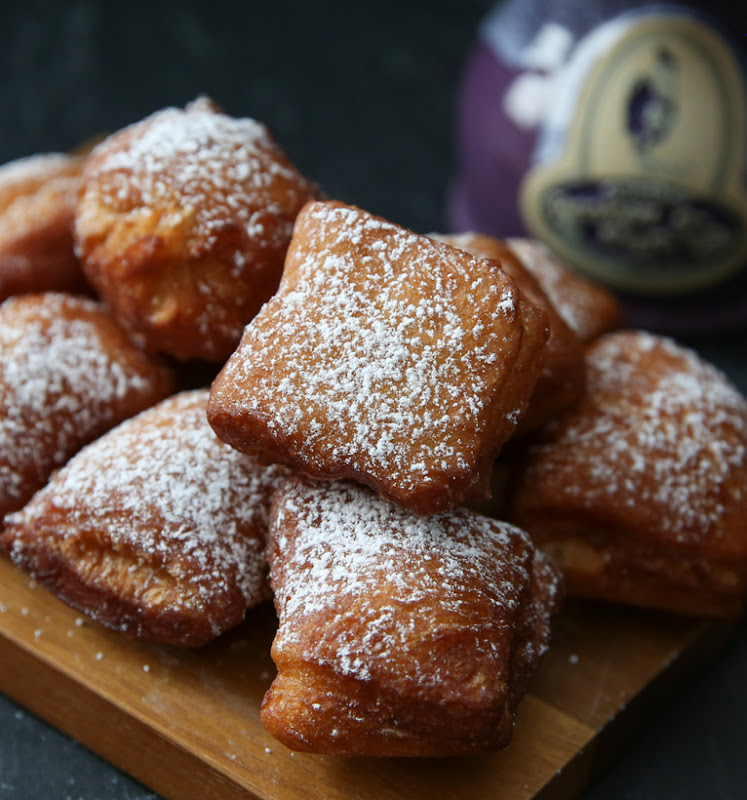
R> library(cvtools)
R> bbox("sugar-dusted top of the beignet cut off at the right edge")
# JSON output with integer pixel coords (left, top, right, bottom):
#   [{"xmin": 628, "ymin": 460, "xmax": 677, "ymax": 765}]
[{"xmin": 526, "ymin": 331, "xmax": 747, "ymax": 541}]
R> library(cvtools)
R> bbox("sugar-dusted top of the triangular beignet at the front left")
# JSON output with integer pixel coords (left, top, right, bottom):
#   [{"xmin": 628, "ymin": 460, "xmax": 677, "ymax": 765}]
[{"xmin": 8, "ymin": 390, "xmax": 284, "ymax": 620}]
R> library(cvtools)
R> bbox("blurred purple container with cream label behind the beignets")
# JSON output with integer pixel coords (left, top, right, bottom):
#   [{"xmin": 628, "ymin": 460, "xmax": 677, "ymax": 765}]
[{"xmin": 447, "ymin": 0, "xmax": 747, "ymax": 330}]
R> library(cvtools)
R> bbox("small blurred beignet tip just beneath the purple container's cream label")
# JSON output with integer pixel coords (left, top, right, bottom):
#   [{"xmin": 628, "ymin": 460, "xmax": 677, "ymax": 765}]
[{"xmin": 506, "ymin": 237, "xmax": 622, "ymax": 342}]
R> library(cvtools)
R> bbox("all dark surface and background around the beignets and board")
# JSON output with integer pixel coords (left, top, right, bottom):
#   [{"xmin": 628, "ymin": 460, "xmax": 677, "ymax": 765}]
[{"xmin": 0, "ymin": 0, "xmax": 747, "ymax": 800}]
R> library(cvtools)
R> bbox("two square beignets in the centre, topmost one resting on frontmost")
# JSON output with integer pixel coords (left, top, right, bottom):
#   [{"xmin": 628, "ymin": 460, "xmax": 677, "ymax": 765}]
[{"xmin": 202, "ymin": 201, "xmax": 560, "ymax": 756}]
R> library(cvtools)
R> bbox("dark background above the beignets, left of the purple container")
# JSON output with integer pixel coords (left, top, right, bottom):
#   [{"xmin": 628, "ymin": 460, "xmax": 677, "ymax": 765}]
[{"xmin": 0, "ymin": 0, "xmax": 488, "ymax": 234}]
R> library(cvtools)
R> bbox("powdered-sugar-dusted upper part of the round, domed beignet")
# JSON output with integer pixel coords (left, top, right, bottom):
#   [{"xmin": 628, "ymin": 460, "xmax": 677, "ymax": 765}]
[{"xmin": 76, "ymin": 98, "xmax": 311, "ymax": 260}]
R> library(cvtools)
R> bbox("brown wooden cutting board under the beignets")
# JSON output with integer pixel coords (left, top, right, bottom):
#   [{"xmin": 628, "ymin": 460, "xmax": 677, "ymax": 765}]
[{"xmin": 0, "ymin": 558, "xmax": 734, "ymax": 800}]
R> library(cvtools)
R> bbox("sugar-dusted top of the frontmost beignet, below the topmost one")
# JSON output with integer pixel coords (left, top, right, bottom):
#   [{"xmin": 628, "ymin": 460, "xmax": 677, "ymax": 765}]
[{"xmin": 268, "ymin": 479, "xmax": 557, "ymax": 686}]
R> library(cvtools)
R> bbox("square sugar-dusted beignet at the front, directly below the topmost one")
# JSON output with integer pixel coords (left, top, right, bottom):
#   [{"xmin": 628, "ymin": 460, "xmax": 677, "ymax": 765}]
[{"xmin": 261, "ymin": 476, "xmax": 562, "ymax": 756}]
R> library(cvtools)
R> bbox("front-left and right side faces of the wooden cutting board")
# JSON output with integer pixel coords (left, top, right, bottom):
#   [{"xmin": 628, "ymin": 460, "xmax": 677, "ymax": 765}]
[{"xmin": 0, "ymin": 568, "xmax": 739, "ymax": 800}]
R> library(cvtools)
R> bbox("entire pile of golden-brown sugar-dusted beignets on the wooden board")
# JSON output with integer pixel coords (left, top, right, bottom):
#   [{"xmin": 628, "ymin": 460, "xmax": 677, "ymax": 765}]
[{"xmin": 5, "ymin": 98, "xmax": 747, "ymax": 756}]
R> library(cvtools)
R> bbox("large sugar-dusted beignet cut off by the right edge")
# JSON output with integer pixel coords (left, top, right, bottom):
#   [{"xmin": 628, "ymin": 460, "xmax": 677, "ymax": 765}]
[{"xmin": 507, "ymin": 331, "xmax": 747, "ymax": 616}]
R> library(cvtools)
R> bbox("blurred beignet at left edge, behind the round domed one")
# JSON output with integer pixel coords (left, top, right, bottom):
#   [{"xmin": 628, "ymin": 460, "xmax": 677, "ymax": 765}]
[{"xmin": 0, "ymin": 153, "xmax": 88, "ymax": 302}]
